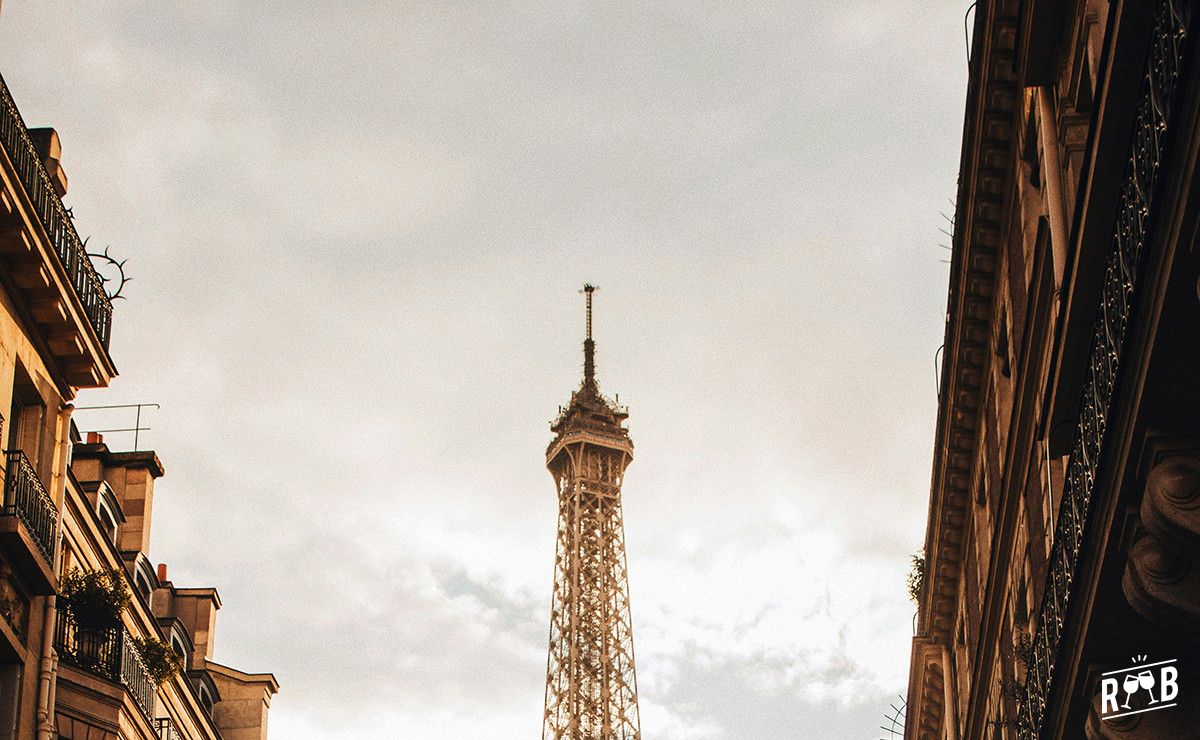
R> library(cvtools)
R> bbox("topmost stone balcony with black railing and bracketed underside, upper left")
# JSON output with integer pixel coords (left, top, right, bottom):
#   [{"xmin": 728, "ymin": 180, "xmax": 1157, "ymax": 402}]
[{"xmin": 0, "ymin": 72, "xmax": 115, "ymax": 387}]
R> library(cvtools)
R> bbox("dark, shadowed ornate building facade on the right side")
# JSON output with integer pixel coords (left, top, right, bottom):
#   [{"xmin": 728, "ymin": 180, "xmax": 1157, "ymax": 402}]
[{"xmin": 906, "ymin": 0, "xmax": 1200, "ymax": 739}]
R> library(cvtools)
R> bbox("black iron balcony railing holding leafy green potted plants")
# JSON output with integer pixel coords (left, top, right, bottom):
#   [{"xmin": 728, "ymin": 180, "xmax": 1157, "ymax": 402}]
[{"xmin": 54, "ymin": 612, "xmax": 157, "ymax": 714}]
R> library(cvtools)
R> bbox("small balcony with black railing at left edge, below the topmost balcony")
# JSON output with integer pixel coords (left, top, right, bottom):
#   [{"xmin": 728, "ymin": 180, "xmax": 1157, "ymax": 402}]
[{"xmin": 0, "ymin": 450, "xmax": 59, "ymax": 595}]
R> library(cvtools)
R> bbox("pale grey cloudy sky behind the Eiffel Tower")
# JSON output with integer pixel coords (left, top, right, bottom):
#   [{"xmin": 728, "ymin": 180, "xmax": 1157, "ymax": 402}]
[{"xmin": 0, "ymin": 0, "xmax": 967, "ymax": 740}]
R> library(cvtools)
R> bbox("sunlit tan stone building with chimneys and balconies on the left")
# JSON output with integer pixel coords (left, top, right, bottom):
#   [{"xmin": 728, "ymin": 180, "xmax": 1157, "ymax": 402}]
[{"xmin": 0, "ymin": 24, "xmax": 278, "ymax": 740}]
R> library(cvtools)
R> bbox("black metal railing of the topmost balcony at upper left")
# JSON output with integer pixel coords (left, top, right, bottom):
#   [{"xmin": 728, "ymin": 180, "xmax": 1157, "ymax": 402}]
[{"xmin": 0, "ymin": 69, "xmax": 113, "ymax": 349}]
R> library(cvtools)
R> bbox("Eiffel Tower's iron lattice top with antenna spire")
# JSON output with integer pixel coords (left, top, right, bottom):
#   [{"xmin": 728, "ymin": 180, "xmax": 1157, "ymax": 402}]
[{"xmin": 541, "ymin": 285, "xmax": 642, "ymax": 740}]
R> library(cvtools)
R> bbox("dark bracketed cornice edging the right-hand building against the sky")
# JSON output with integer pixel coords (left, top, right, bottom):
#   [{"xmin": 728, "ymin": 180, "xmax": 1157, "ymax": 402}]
[{"xmin": 920, "ymin": 0, "xmax": 1021, "ymax": 644}]
